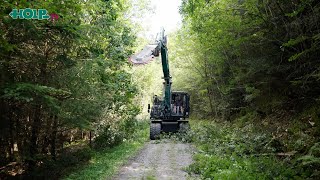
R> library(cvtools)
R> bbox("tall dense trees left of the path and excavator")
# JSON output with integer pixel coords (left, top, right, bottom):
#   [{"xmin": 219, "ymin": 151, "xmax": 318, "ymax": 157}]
[{"xmin": 0, "ymin": 0, "xmax": 139, "ymax": 177}]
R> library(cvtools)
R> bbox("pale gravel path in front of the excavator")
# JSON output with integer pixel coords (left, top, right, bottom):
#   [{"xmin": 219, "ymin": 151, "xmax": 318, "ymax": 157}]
[{"xmin": 114, "ymin": 141, "xmax": 194, "ymax": 180}]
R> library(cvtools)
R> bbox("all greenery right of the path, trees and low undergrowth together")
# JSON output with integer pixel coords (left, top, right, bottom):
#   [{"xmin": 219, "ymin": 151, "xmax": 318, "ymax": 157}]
[{"xmin": 173, "ymin": 0, "xmax": 320, "ymax": 179}]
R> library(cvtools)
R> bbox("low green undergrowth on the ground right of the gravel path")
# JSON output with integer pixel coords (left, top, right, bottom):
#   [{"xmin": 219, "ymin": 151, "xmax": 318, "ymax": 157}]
[{"xmin": 185, "ymin": 116, "xmax": 320, "ymax": 179}]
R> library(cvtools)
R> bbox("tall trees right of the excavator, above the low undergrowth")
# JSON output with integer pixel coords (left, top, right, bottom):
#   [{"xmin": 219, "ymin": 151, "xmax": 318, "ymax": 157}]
[{"xmin": 179, "ymin": 0, "xmax": 320, "ymax": 119}]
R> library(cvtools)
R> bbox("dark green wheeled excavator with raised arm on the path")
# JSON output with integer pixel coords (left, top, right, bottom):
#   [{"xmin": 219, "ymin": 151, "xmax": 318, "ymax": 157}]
[{"xmin": 131, "ymin": 28, "xmax": 190, "ymax": 140}]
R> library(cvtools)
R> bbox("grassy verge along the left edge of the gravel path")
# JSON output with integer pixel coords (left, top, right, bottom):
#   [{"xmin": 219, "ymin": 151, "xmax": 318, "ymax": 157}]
[{"xmin": 23, "ymin": 121, "xmax": 149, "ymax": 179}]
